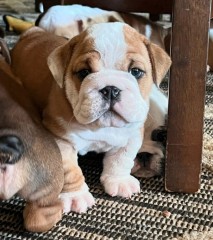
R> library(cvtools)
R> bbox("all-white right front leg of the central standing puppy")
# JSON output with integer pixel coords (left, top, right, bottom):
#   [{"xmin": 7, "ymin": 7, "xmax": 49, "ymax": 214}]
[{"xmin": 101, "ymin": 130, "xmax": 142, "ymax": 198}]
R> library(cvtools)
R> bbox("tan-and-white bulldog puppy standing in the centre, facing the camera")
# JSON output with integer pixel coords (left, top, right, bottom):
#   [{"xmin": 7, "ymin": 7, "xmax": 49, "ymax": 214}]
[{"xmin": 12, "ymin": 22, "xmax": 171, "ymax": 212}]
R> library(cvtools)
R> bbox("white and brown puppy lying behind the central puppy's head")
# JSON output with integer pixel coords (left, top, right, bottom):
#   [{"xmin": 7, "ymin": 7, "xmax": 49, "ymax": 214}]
[{"xmin": 36, "ymin": 4, "xmax": 170, "ymax": 48}]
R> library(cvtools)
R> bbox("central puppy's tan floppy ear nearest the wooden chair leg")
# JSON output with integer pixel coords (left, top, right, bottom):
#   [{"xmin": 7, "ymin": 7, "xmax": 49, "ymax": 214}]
[{"xmin": 144, "ymin": 39, "xmax": 172, "ymax": 86}]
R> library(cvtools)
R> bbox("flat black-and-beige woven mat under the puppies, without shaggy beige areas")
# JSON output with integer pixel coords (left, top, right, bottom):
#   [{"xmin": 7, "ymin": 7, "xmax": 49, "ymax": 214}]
[{"xmin": 0, "ymin": 160, "xmax": 213, "ymax": 240}]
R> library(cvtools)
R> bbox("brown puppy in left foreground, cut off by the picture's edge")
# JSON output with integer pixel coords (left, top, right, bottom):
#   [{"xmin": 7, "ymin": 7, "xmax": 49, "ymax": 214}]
[{"xmin": 0, "ymin": 42, "xmax": 64, "ymax": 232}]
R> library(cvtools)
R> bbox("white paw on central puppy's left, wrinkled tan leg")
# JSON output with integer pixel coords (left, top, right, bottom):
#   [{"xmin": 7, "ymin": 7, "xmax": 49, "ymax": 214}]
[{"xmin": 60, "ymin": 184, "xmax": 95, "ymax": 213}]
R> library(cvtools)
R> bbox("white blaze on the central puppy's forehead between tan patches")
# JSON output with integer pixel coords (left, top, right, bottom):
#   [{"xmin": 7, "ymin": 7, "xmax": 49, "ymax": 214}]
[{"xmin": 89, "ymin": 23, "xmax": 127, "ymax": 68}]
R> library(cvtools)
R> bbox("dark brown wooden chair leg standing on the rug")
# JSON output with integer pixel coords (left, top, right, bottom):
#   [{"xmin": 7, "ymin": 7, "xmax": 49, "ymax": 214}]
[{"xmin": 165, "ymin": 0, "xmax": 211, "ymax": 193}]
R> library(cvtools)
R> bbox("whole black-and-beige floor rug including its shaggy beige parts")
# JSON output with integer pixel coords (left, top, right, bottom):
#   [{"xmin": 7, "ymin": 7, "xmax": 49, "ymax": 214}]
[{"xmin": 0, "ymin": 0, "xmax": 213, "ymax": 240}]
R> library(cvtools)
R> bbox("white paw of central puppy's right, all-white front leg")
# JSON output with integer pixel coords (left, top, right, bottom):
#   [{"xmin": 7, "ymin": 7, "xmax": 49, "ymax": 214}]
[{"xmin": 101, "ymin": 175, "xmax": 140, "ymax": 198}]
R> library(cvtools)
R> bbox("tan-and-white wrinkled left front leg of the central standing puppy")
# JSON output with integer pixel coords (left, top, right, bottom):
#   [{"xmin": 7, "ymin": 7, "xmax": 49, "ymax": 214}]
[{"xmin": 57, "ymin": 139, "xmax": 95, "ymax": 213}]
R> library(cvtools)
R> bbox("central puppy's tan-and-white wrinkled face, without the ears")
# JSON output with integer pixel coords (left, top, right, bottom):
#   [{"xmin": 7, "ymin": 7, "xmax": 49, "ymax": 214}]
[{"xmin": 49, "ymin": 23, "xmax": 171, "ymax": 127}]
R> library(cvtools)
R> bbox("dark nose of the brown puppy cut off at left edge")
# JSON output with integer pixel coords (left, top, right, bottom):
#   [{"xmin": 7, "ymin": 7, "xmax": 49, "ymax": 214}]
[{"xmin": 0, "ymin": 135, "xmax": 24, "ymax": 164}]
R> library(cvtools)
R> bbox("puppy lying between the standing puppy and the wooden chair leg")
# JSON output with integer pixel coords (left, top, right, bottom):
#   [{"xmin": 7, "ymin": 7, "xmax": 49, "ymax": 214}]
[{"xmin": 131, "ymin": 85, "xmax": 168, "ymax": 178}]
